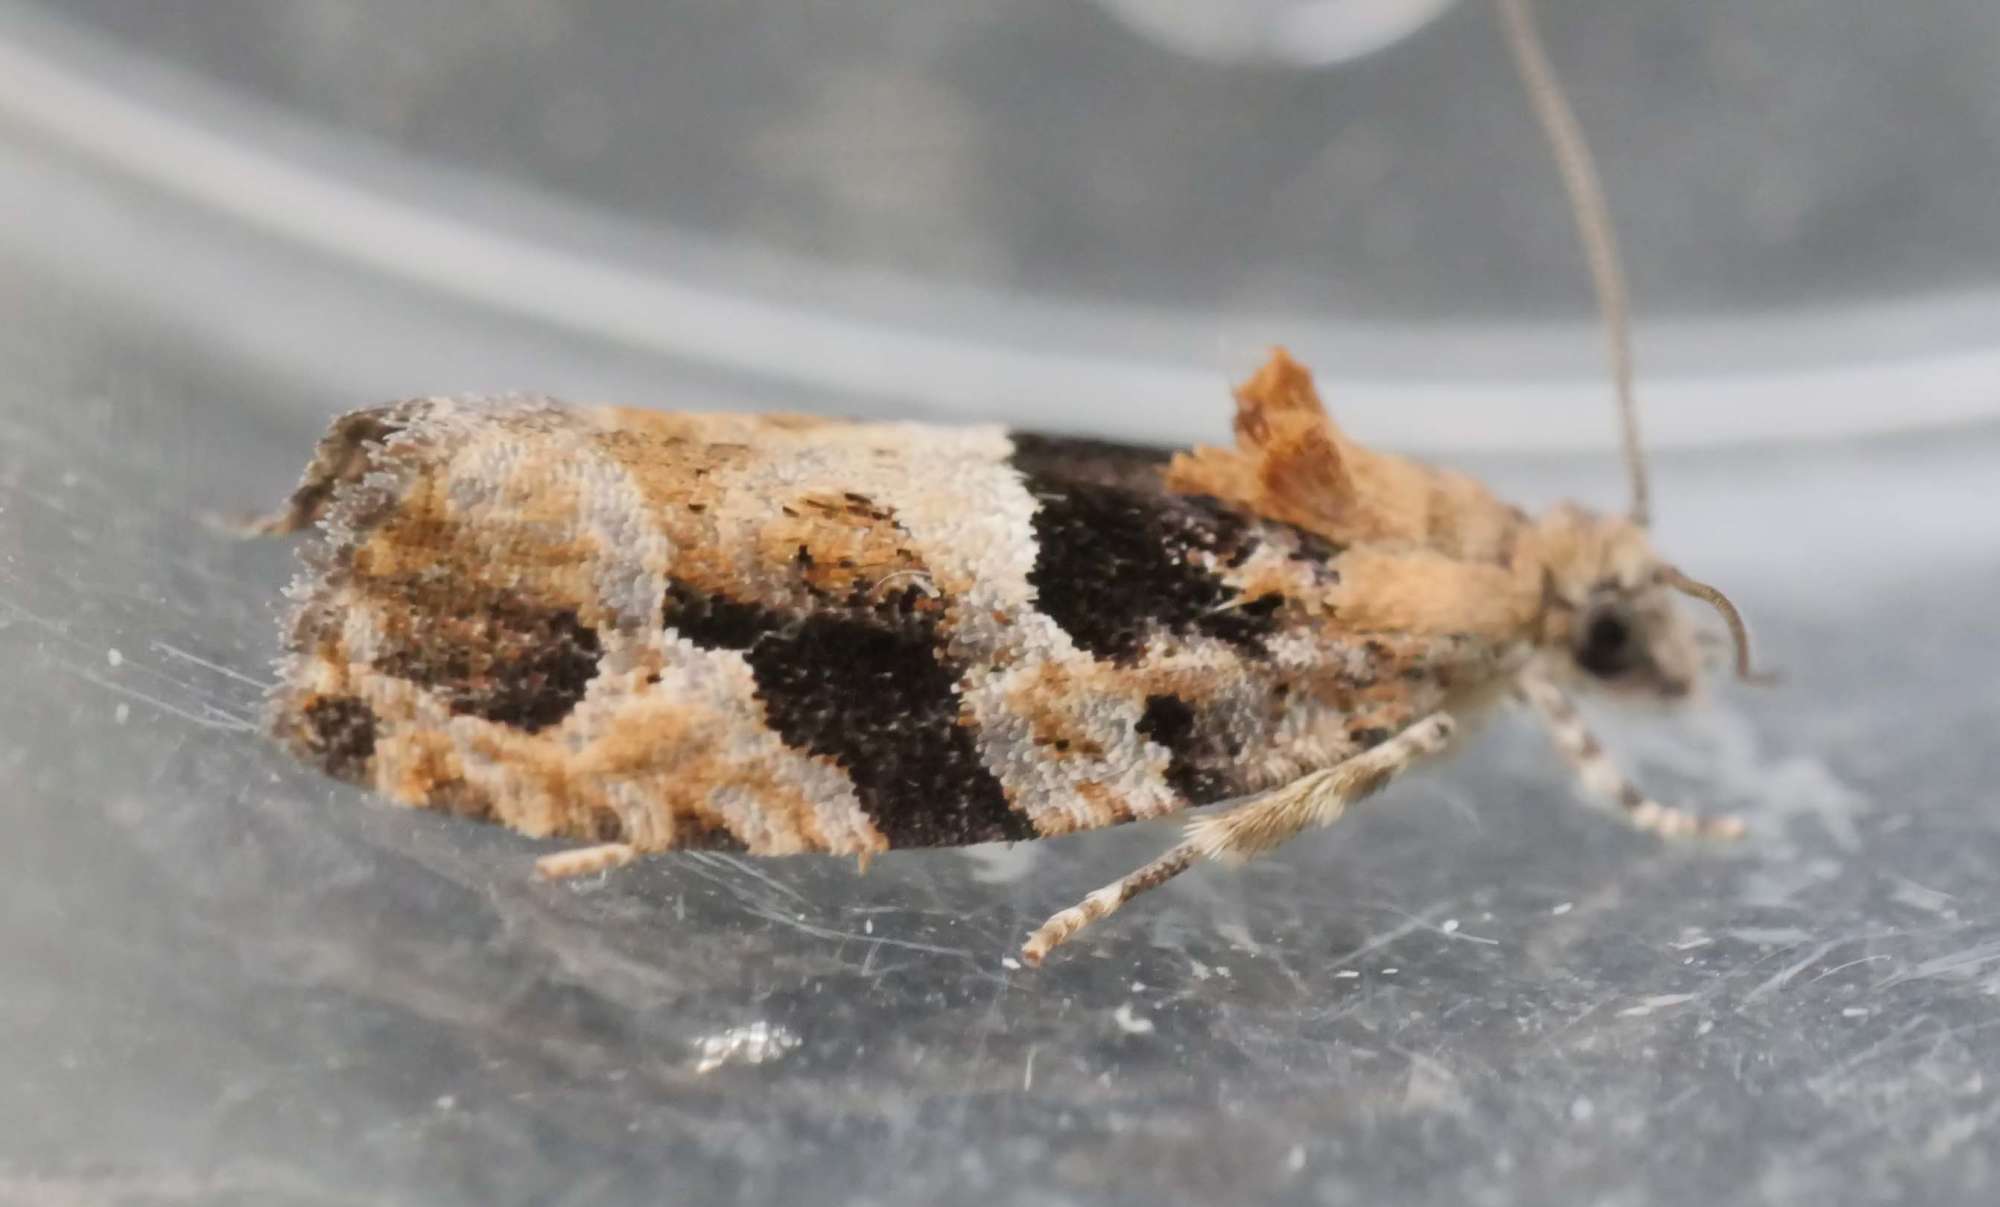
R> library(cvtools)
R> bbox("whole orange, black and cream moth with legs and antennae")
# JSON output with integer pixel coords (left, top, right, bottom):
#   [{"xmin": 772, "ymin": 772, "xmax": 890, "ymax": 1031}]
[{"xmin": 260, "ymin": 0, "xmax": 1752, "ymax": 963}]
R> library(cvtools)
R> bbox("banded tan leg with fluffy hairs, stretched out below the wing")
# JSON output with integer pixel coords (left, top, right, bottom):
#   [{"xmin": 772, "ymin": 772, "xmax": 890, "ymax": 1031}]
[{"xmin": 1020, "ymin": 713, "xmax": 1456, "ymax": 967}]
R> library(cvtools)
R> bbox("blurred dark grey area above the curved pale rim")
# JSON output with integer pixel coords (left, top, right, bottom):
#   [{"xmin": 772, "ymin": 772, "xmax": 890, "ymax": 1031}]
[{"xmin": 35, "ymin": 0, "xmax": 2000, "ymax": 322}]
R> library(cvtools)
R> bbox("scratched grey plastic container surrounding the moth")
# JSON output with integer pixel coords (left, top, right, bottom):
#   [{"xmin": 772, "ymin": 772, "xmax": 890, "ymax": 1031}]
[{"xmin": 0, "ymin": 0, "xmax": 2000, "ymax": 1205}]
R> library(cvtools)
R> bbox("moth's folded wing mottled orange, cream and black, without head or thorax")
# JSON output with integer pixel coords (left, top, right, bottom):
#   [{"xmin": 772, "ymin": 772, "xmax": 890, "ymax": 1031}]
[{"xmin": 272, "ymin": 353, "xmax": 1494, "ymax": 853}]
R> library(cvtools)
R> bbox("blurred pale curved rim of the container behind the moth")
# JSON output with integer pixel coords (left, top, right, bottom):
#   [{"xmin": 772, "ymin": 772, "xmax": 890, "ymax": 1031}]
[{"xmin": 0, "ymin": 8, "xmax": 2000, "ymax": 450}]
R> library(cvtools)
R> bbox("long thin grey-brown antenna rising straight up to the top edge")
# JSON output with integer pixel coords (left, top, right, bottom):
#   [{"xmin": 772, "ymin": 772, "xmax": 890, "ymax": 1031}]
[{"xmin": 1498, "ymin": 0, "xmax": 1652, "ymax": 528}]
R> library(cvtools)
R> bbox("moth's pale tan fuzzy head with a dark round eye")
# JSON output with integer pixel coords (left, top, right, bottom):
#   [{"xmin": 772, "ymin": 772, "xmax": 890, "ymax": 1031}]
[{"xmin": 1538, "ymin": 506, "xmax": 1762, "ymax": 699}]
